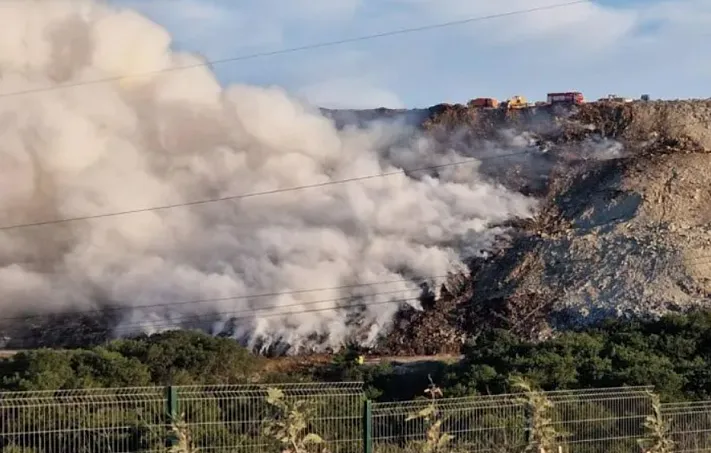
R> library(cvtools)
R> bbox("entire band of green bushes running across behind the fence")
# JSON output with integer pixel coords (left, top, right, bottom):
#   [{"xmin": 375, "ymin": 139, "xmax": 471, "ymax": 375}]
[{"xmin": 0, "ymin": 311, "xmax": 711, "ymax": 401}]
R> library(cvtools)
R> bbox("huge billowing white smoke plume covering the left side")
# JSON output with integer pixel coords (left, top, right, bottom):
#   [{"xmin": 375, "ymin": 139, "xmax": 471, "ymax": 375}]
[{"xmin": 0, "ymin": 0, "xmax": 535, "ymax": 354}]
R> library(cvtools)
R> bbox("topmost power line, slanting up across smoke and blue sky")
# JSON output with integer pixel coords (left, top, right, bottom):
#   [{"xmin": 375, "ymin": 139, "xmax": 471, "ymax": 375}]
[{"xmin": 0, "ymin": 0, "xmax": 590, "ymax": 98}]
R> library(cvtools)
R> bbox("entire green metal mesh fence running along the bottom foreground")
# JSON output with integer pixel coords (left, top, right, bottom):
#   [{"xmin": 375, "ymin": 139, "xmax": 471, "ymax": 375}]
[{"xmin": 8, "ymin": 383, "xmax": 711, "ymax": 453}]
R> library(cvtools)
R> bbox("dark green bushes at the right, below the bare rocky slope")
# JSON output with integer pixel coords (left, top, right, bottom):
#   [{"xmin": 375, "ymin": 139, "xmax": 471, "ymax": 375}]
[{"xmin": 446, "ymin": 312, "xmax": 711, "ymax": 401}]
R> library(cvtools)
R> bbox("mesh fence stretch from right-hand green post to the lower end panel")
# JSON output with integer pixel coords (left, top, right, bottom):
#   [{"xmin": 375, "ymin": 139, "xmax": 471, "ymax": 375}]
[{"xmin": 372, "ymin": 387, "xmax": 651, "ymax": 453}]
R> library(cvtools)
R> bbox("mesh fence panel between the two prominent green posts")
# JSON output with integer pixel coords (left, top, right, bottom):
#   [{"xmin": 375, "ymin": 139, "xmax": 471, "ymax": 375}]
[{"xmin": 177, "ymin": 383, "xmax": 364, "ymax": 453}]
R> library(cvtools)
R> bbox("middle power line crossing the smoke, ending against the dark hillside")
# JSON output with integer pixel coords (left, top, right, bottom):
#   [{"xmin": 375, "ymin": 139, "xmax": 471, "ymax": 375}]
[{"xmin": 0, "ymin": 151, "xmax": 530, "ymax": 231}]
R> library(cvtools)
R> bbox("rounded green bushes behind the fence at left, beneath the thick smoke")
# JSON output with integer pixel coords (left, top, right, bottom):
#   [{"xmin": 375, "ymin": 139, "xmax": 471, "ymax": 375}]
[{"xmin": 0, "ymin": 331, "xmax": 261, "ymax": 390}]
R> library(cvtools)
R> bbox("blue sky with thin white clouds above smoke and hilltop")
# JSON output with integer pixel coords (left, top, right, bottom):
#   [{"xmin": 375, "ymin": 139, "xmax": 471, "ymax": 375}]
[{"xmin": 111, "ymin": 0, "xmax": 711, "ymax": 108}]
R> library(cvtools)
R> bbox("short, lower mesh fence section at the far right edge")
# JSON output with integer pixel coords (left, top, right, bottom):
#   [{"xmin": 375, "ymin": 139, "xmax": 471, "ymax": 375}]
[{"xmin": 662, "ymin": 401, "xmax": 711, "ymax": 453}]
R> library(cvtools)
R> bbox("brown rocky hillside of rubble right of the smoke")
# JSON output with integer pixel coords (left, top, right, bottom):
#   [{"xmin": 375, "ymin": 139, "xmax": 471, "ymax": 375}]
[{"xmin": 383, "ymin": 101, "xmax": 711, "ymax": 353}]
